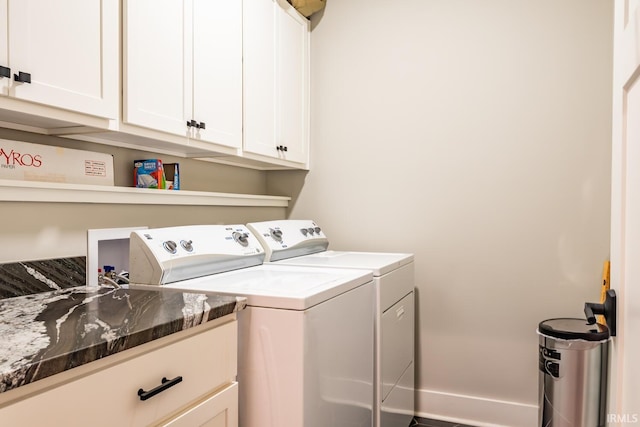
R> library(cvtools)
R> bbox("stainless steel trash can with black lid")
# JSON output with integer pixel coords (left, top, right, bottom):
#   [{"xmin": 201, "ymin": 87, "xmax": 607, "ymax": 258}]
[{"xmin": 538, "ymin": 318, "xmax": 610, "ymax": 427}]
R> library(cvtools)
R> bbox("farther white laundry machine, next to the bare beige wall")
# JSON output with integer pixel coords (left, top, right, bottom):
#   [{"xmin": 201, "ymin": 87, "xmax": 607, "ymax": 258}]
[{"xmin": 247, "ymin": 220, "xmax": 415, "ymax": 427}]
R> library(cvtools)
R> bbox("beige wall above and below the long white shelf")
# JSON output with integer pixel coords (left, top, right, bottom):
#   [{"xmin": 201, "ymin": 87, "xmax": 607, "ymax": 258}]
[{"xmin": 0, "ymin": 129, "xmax": 285, "ymax": 263}]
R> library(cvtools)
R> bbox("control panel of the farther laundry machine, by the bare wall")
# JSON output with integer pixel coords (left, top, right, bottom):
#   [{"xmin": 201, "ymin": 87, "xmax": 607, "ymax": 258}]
[{"xmin": 247, "ymin": 219, "xmax": 329, "ymax": 261}]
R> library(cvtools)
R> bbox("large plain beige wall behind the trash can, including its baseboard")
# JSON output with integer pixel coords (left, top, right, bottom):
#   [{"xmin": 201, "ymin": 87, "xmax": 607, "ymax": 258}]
[{"xmin": 268, "ymin": 0, "xmax": 612, "ymax": 427}]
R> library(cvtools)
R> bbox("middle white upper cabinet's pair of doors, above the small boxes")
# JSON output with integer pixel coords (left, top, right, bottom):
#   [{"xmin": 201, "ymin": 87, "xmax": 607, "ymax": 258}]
[{"xmin": 123, "ymin": 0, "xmax": 242, "ymax": 148}]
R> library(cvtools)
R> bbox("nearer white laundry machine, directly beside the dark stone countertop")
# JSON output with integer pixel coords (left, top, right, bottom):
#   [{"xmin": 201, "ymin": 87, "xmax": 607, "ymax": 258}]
[{"xmin": 129, "ymin": 225, "xmax": 374, "ymax": 427}]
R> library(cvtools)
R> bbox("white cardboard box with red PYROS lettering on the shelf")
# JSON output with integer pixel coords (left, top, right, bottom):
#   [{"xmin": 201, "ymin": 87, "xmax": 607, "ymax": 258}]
[{"xmin": 0, "ymin": 139, "xmax": 114, "ymax": 186}]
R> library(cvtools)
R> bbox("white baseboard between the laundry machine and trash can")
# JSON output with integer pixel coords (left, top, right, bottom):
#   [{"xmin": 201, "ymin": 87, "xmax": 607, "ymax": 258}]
[{"xmin": 416, "ymin": 390, "xmax": 538, "ymax": 427}]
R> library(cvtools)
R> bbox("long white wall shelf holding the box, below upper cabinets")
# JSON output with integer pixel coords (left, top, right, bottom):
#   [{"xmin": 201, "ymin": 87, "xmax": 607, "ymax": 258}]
[{"xmin": 0, "ymin": 180, "xmax": 291, "ymax": 207}]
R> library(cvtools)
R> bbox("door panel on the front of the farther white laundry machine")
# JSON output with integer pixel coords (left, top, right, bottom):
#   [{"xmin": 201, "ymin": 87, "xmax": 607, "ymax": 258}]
[{"xmin": 380, "ymin": 292, "xmax": 415, "ymax": 400}]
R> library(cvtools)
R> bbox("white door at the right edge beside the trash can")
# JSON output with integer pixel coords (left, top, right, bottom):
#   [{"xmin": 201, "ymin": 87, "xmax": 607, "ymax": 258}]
[{"xmin": 608, "ymin": 0, "xmax": 640, "ymax": 426}]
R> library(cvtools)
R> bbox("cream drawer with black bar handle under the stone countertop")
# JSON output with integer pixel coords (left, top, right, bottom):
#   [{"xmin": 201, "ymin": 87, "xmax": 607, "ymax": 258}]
[{"xmin": 0, "ymin": 321, "xmax": 237, "ymax": 427}]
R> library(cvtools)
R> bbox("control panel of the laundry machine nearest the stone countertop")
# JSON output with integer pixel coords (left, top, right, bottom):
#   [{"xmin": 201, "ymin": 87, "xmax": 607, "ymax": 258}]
[{"xmin": 129, "ymin": 225, "xmax": 265, "ymax": 284}]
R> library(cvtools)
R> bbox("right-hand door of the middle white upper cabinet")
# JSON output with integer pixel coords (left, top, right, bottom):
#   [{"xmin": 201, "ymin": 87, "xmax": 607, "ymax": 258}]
[{"xmin": 192, "ymin": 0, "xmax": 242, "ymax": 148}]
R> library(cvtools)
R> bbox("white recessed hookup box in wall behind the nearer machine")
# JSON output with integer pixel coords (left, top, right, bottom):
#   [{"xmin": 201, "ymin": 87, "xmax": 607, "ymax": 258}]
[{"xmin": 87, "ymin": 226, "xmax": 149, "ymax": 286}]
